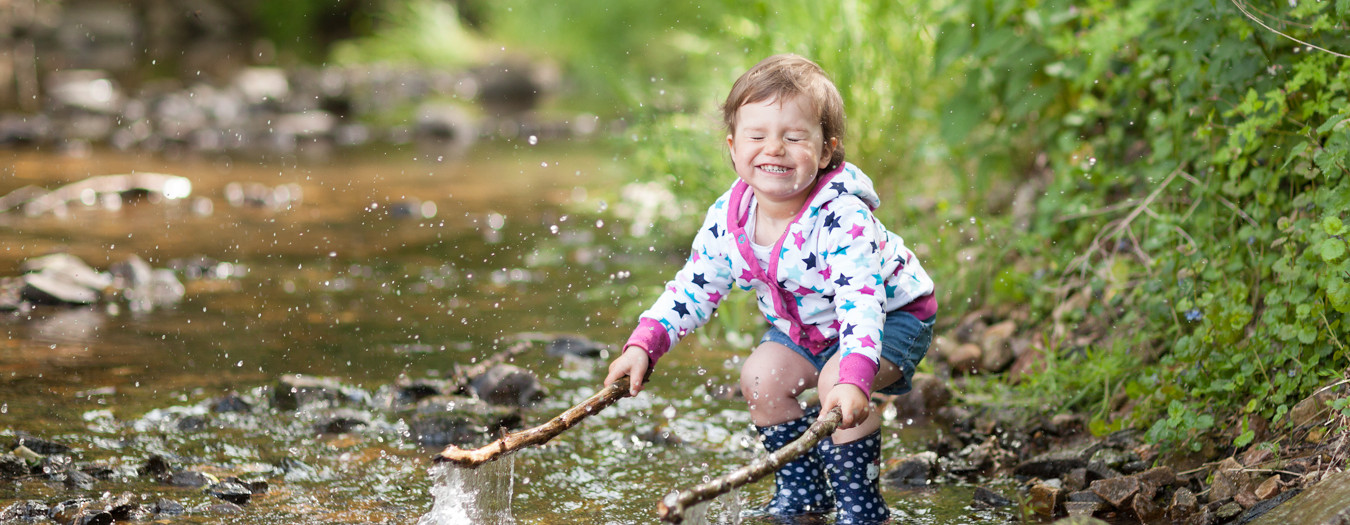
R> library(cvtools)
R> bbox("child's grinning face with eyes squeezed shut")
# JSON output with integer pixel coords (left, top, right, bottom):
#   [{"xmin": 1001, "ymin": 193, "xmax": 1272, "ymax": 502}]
[{"xmin": 726, "ymin": 96, "xmax": 838, "ymax": 212}]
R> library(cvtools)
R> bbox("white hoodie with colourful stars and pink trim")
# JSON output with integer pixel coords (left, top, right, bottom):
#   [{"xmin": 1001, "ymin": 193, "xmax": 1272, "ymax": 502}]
[{"xmin": 626, "ymin": 163, "xmax": 937, "ymax": 394}]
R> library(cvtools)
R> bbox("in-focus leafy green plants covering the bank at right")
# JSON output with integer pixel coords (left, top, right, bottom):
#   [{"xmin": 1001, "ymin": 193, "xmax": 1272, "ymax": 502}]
[{"xmin": 937, "ymin": 0, "xmax": 1350, "ymax": 447}]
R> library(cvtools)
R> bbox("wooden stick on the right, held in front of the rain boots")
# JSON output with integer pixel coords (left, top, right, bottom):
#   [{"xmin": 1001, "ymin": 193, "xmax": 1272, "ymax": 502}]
[{"xmin": 656, "ymin": 408, "xmax": 844, "ymax": 524}]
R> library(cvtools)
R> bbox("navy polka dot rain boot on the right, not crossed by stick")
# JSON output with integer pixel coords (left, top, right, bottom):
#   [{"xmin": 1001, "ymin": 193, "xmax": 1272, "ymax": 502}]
[{"xmin": 817, "ymin": 431, "xmax": 891, "ymax": 525}]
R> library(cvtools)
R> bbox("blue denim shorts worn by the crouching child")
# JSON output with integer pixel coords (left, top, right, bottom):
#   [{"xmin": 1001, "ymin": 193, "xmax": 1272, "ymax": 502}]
[{"xmin": 760, "ymin": 310, "xmax": 937, "ymax": 395}]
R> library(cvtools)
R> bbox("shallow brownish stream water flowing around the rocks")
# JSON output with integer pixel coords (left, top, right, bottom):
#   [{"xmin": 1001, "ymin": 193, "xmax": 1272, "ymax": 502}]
[{"xmin": 0, "ymin": 142, "xmax": 1014, "ymax": 524}]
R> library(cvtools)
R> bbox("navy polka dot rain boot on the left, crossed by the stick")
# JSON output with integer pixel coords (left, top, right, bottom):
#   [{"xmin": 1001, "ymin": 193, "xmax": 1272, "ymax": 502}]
[{"xmin": 756, "ymin": 408, "xmax": 834, "ymax": 517}]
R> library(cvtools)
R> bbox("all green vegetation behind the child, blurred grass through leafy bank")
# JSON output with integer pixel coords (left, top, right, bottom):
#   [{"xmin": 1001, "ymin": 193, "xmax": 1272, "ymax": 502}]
[{"xmin": 193, "ymin": 0, "xmax": 1350, "ymax": 451}]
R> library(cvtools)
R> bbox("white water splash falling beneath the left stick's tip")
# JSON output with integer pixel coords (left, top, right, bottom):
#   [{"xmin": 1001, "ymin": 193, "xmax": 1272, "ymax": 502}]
[{"xmin": 417, "ymin": 455, "xmax": 516, "ymax": 525}]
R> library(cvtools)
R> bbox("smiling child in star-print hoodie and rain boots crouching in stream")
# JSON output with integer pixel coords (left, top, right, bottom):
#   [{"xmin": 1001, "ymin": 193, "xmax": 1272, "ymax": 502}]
[{"xmin": 605, "ymin": 55, "xmax": 937, "ymax": 524}]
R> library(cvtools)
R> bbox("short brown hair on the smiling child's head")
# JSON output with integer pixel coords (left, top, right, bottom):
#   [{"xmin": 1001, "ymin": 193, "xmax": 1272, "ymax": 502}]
[{"xmin": 722, "ymin": 54, "xmax": 844, "ymax": 173}]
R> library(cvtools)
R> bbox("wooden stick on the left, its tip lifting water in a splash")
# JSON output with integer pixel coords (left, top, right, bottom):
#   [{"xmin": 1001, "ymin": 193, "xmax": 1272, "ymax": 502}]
[{"xmin": 432, "ymin": 375, "xmax": 629, "ymax": 468}]
